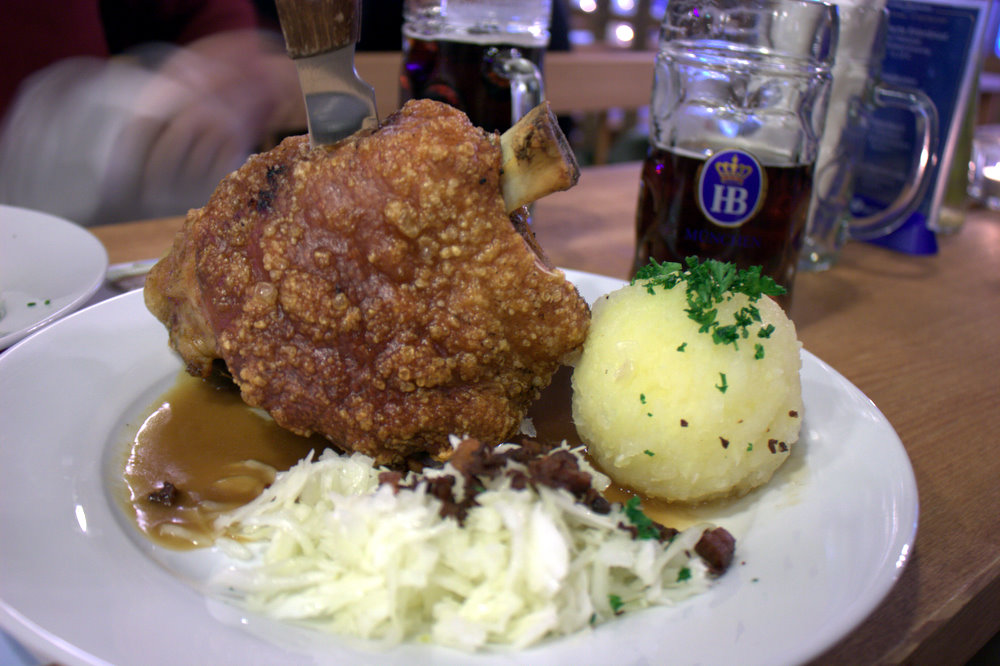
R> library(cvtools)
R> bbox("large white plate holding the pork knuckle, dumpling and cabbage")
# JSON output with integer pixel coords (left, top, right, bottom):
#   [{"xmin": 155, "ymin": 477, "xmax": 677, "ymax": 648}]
[{"xmin": 0, "ymin": 271, "xmax": 917, "ymax": 666}]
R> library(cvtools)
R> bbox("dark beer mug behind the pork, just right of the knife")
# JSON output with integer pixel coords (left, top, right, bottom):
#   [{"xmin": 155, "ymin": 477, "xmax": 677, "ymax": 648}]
[{"xmin": 400, "ymin": 0, "xmax": 552, "ymax": 132}]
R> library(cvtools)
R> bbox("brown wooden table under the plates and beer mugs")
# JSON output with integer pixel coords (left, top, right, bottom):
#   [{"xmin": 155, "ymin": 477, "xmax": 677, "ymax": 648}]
[{"xmin": 94, "ymin": 164, "xmax": 1000, "ymax": 665}]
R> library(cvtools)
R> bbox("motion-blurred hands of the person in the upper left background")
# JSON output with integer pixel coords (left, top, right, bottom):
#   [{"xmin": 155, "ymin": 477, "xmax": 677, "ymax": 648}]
[{"xmin": 0, "ymin": 32, "xmax": 305, "ymax": 225}]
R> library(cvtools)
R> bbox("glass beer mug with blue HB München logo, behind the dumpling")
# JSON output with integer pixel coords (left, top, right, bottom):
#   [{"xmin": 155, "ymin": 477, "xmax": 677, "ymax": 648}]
[{"xmin": 633, "ymin": 0, "xmax": 838, "ymax": 307}]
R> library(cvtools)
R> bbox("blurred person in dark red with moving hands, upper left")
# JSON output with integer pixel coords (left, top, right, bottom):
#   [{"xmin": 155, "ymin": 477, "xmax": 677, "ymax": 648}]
[{"xmin": 0, "ymin": 0, "xmax": 305, "ymax": 225}]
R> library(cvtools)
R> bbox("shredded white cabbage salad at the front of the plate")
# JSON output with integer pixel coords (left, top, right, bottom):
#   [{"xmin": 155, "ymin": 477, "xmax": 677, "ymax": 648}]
[{"xmin": 214, "ymin": 445, "xmax": 728, "ymax": 651}]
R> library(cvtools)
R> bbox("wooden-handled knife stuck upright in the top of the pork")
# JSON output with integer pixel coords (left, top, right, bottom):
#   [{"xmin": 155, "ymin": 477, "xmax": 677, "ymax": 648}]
[{"xmin": 275, "ymin": 0, "xmax": 378, "ymax": 146}]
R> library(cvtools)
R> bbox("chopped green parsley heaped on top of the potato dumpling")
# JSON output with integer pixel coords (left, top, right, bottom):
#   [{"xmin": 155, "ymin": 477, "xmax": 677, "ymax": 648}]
[{"xmin": 632, "ymin": 257, "xmax": 786, "ymax": 359}]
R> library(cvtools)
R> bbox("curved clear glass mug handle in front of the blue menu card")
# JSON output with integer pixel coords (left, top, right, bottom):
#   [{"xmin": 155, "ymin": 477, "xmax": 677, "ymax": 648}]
[{"xmin": 849, "ymin": 81, "xmax": 938, "ymax": 240}]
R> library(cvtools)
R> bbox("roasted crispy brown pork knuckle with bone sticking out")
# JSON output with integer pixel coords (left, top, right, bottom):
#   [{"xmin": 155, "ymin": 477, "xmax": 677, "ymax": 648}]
[{"xmin": 145, "ymin": 100, "xmax": 590, "ymax": 463}]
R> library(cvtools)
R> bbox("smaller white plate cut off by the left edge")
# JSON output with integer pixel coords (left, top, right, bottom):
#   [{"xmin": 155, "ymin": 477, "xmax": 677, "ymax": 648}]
[{"xmin": 0, "ymin": 205, "xmax": 108, "ymax": 350}]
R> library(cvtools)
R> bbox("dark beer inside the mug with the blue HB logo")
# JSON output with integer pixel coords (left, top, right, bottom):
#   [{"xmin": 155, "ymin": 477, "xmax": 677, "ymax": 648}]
[{"xmin": 633, "ymin": 148, "xmax": 812, "ymax": 305}]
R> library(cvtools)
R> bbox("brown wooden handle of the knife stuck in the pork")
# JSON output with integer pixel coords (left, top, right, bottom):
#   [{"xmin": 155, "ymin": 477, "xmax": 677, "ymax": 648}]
[{"xmin": 274, "ymin": 0, "xmax": 361, "ymax": 59}]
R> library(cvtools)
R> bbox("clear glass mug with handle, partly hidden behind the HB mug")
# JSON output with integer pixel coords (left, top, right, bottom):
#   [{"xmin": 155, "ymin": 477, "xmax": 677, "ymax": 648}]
[{"xmin": 799, "ymin": 0, "xmax": 938, "ymax": 270}]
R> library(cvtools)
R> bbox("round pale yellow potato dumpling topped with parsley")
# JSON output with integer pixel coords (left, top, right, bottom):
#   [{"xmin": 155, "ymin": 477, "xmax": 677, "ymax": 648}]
[{"xmin": 573, "ymin": 262, "xmax": 802, "ymax": 503}]
